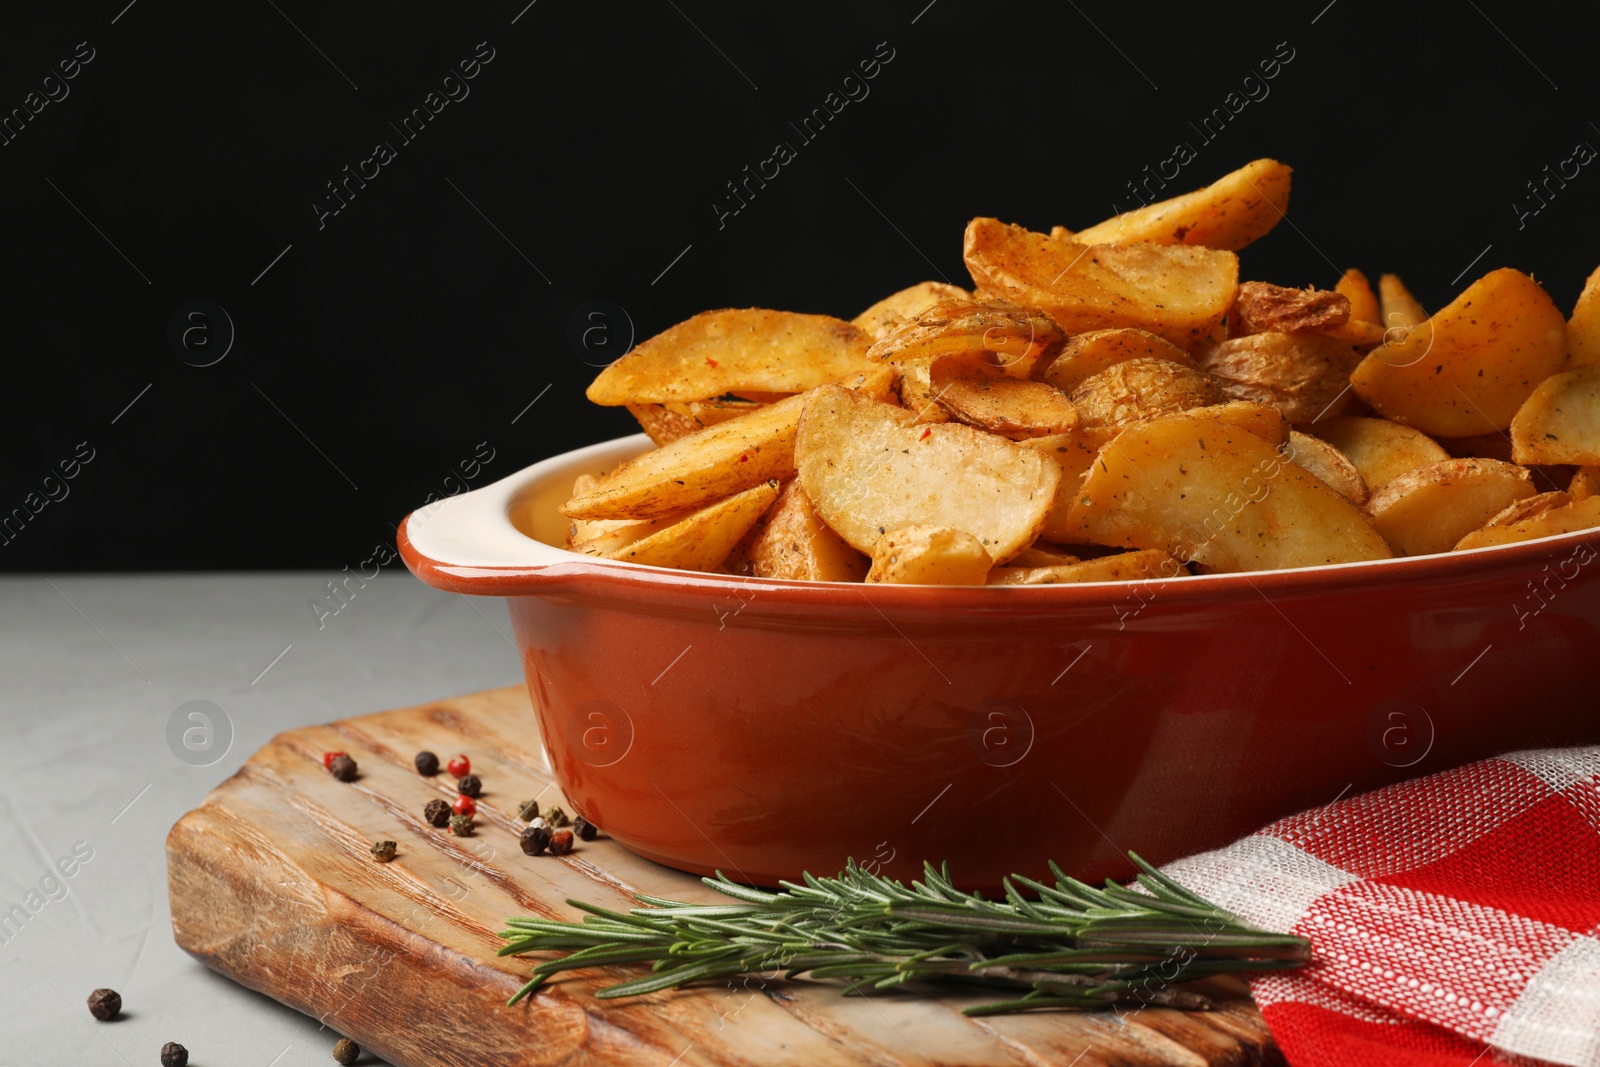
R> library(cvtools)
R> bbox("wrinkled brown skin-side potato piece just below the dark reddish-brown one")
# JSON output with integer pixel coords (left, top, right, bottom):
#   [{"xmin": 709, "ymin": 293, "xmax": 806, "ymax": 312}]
[{"xmin": 1195, "ymin": 333, "xmax": 1362, "ymax": 424}]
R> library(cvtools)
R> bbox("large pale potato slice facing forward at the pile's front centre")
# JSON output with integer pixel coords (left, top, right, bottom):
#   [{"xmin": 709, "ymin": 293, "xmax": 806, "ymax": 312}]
[{"xmin": 795, "ymin": 386, "xmax": 1061, "ymax": 563}]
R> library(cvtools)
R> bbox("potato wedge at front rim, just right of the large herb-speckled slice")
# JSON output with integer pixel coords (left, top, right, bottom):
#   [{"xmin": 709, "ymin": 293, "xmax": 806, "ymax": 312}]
[{"xmin": 1366, "ymin": 459, "xmax": 1533, "ymax": 555}]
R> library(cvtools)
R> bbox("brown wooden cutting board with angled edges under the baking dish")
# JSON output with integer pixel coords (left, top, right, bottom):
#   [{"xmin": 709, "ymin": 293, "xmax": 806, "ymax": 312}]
[{"xmin": 166, "ymin": 686, "xmax": 1282, "ymax": 1067}]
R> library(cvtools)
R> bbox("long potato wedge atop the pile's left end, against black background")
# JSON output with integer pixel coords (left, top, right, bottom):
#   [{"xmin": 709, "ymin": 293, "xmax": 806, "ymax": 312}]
[{"xmin": 587, "ymin": 307, "xmax": 872, "ymax": 406}]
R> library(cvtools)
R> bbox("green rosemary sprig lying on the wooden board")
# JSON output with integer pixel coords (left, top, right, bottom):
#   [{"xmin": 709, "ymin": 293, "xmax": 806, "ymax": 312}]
[{"xmin": 499, "ymin": 853, "xmax": 1310, "ymax": 1016}]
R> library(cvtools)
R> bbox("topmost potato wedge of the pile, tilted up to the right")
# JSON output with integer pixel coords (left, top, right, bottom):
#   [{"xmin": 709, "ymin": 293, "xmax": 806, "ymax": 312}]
[{"xmin": 1072, "ymin": 160, "xmax": 1293, "ymax": 251}]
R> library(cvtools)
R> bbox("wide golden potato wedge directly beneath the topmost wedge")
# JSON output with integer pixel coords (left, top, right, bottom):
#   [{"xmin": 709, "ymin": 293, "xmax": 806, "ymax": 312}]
[{"xmin": 963, "ymin": 218, "xmax": 1238, "ymax": 347}]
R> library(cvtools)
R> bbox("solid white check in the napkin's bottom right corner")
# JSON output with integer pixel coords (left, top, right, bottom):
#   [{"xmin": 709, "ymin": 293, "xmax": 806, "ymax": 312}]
[{"xmin": 1488, "ymin": 937, "xmax": 1600, "ymax": 1067}]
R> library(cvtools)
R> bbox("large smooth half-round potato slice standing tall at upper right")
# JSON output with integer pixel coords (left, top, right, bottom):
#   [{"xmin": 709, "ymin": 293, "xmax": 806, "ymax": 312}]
[{"xmin": 1350, "ymin": 267, "xmax": 1566, "ymax": 437}]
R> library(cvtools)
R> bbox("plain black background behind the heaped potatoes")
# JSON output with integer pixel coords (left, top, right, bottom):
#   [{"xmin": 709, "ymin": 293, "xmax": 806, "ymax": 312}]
[{"xmin": 0, "ymin": 0, "xmax": 1600, "ymax": 569}]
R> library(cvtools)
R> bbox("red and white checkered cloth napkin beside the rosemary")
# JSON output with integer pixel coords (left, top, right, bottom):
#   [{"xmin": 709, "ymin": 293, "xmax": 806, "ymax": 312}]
[{"xmin": 1165, "ymin": 747, "xmax": 1600, "ymax": 1067}]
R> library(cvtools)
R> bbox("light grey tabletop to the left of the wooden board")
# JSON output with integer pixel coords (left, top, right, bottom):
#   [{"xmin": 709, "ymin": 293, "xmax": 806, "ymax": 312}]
[{"xmin": 0, "ymin": 571, "xmax": 522, "ymax": 1067}]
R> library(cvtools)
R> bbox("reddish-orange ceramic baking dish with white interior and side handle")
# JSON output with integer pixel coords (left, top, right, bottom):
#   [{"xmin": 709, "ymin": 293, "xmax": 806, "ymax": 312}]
[{"xmin": 398, "ymin": 437, "xmax": 1600, "ymax": 888}]
